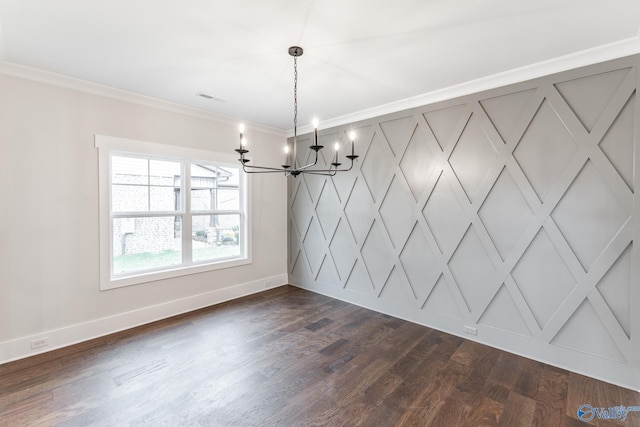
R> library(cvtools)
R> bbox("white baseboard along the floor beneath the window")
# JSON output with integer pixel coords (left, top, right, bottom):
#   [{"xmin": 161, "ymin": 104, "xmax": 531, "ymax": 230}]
[{"xmin": 0, "ymin": 274, "xmax": 287, "ymax": 364}]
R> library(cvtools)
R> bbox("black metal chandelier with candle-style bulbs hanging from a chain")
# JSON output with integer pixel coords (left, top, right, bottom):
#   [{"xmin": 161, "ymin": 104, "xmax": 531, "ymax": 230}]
[{"xmin": 235, "ymin": 46, "xmax": 358, "ymax": 177}]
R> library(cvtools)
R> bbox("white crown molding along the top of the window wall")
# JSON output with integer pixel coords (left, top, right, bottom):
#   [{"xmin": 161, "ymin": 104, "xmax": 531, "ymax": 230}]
[{"xmin": 0, "ymin": 61, "xmax": 286, "ymax": 138}]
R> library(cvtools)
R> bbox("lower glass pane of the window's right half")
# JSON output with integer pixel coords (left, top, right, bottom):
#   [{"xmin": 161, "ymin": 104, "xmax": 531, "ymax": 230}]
[{"xmin": 191, "ymin": 215, "xmax": 241, "ymax": 262}]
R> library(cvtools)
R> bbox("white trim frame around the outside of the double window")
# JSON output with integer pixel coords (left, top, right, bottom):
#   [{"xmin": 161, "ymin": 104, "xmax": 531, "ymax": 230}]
[{"xmin": 95, "ymin": 135, "xmax": 252, "ymax": 291}]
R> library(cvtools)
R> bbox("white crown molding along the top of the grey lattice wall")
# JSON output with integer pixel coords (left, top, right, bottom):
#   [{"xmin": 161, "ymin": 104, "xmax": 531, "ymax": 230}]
[{"xmin": 298, "ymin": 34, "xmax": 640, "ymax": 137}]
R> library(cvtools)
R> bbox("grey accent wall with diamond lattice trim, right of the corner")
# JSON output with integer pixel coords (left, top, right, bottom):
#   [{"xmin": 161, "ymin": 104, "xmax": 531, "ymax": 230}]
[{"xmin": 289, "ymin": 55, "xmax": 640, "ymax": 390}]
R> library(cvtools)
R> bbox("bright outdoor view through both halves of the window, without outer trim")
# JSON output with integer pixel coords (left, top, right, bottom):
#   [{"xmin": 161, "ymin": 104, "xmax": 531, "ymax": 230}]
[{"xmin": 109, "ymin": 152, "xmax": 244, "ymax": 278}]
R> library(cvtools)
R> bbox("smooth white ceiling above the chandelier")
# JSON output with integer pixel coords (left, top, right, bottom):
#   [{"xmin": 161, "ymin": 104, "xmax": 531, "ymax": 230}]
[{"xmin": 0, "ymin": 0, "xmax": 640, "ymax": 130}]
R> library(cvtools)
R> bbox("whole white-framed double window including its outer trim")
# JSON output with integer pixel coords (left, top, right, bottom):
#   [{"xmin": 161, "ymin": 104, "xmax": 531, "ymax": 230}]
[{"xmin": 96, "ymin": 136, "xmax": 249, "ymax": 289}]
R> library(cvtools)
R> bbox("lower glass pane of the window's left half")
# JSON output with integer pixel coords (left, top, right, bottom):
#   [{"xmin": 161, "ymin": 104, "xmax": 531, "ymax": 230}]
[{"xmin": 112, "ymin": 216, "xmax": 182, "ymax": 275}]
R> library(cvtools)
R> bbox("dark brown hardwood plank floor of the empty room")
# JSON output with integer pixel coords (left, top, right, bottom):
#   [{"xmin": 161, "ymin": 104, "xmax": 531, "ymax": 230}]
[{"xmin": 0, "ymin": 286, "xmax": 640, "ymax": 427}]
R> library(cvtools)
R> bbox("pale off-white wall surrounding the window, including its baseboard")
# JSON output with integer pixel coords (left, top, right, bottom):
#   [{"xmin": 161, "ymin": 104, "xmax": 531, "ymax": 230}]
[{"xmin": 0, "ymin": 75, "xmax": 287, "ymax": 363}]
